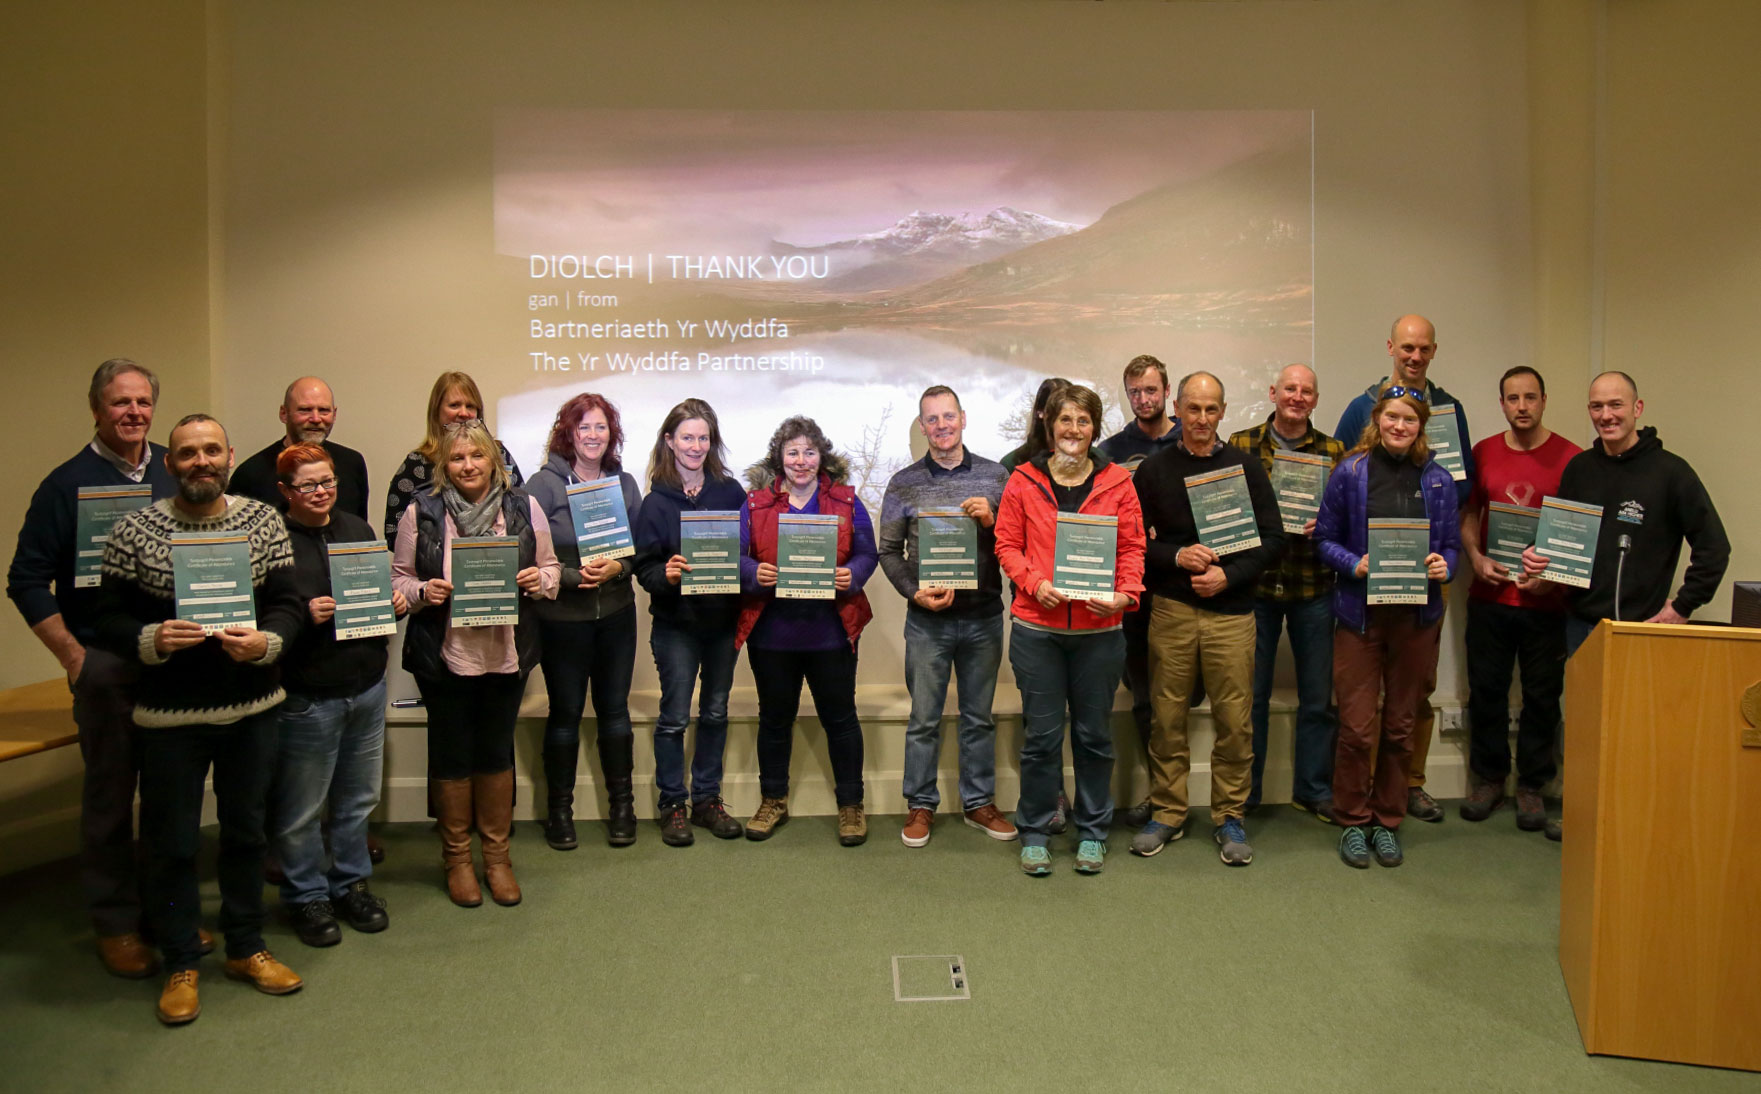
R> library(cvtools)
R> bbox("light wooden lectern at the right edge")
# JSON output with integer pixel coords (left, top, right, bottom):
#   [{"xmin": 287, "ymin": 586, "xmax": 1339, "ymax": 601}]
[{"xmin": 1558, "ymin": 622, "xmax": 1761, "ymax": 1071}]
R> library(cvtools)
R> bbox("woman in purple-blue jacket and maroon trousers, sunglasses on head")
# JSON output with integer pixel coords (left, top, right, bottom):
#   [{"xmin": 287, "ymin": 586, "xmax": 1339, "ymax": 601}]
[{"xmin": 1314, "ymin": 384, "xmax": 1462, "ymax": 869}]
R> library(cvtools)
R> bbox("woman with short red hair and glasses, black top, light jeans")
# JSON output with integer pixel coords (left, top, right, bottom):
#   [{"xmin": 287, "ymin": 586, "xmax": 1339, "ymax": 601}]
[{"xmin": 269, "ymin": 444, "xmax": 409, "ymax": 946}]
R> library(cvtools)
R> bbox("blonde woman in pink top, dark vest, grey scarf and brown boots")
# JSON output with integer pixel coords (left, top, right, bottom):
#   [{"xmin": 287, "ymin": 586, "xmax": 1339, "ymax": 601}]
[{"xmin": 391, "ymin": 418, "xmax": 562, "ymax": 907}]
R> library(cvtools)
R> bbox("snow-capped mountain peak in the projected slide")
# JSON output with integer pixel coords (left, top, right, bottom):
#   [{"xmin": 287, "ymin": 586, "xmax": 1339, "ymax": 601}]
[{"xmin": 771, "ymin": 206, "xmax": 1083, "ymax": 291}]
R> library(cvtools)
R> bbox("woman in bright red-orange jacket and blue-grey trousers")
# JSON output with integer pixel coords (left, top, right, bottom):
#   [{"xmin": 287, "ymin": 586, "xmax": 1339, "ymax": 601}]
[{"xmin": 997, "ymin": 384, "xmax": 1143, "ymax": 877}]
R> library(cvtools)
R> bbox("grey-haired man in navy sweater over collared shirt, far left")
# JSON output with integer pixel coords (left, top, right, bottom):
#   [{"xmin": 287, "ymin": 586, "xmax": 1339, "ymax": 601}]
[{"xmin": 5, "ymin": 358, "xmax": 176, "ymax": 979}]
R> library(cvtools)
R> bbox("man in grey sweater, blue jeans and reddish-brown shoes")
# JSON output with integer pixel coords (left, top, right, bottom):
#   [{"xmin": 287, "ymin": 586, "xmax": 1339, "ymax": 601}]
[{"xmin": 879, "ymin": 386, "xmax": 1016, "ymax": 847}]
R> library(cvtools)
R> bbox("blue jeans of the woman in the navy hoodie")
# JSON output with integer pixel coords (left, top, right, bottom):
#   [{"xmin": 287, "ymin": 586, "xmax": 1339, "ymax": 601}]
[{"xmin": 648, "ymin": 618, "xmax": 738, "ymax": 809}]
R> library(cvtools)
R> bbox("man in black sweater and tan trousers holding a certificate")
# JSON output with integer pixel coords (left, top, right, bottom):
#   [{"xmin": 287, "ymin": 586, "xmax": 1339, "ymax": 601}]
[{"xmin": 1131, "ymin": 372, "xmax": 1284, "ymax": 867}]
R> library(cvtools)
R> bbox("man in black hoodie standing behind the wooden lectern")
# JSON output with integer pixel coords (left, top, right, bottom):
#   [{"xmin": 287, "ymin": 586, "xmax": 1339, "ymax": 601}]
[{"xmin": 1523, "ymin": 372, "xmax": 1731, "ymax": 657}]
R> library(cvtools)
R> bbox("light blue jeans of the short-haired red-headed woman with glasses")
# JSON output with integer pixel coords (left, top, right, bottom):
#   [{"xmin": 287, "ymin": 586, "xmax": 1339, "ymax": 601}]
[{"xmin": 269, "ymin": 680, "xmax": 386, "ymax": 906}]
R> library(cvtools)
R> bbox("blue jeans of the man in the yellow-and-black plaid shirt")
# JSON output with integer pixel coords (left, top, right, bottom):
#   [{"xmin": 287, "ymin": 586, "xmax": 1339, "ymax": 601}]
[{"xmin": 1247, "ymin": 595, "xmax": 1337, "ymax": 807}]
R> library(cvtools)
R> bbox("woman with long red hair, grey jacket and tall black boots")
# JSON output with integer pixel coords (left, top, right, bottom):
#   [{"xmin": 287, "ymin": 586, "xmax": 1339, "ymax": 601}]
[{"xmin": 527, "ymin": 391, "xmax": 641, "ymax": 851}]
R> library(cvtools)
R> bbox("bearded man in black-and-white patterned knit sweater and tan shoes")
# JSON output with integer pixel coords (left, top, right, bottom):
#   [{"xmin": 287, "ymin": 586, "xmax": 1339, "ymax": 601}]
[{"xmin": 97, "ymin": 414, "xmax": 301, "ymax": 1025}]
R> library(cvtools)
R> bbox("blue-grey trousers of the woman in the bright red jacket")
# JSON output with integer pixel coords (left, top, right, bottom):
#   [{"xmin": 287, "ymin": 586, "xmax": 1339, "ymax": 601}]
[{"xmin": 1009, "ymin": 622, "xmax": 1125, "ymax": 847}]
